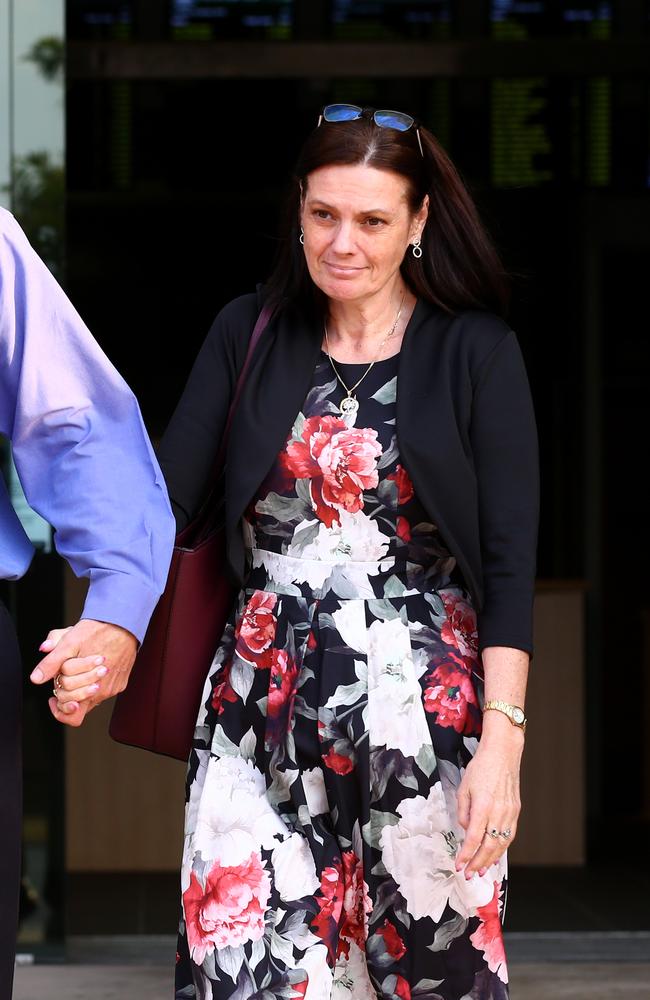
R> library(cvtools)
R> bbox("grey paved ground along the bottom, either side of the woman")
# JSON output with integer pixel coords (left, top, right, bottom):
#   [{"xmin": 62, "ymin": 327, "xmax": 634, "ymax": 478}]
[{"xmin": 13, "ymin": 962, "xmax": 650, "ymax": 1000}]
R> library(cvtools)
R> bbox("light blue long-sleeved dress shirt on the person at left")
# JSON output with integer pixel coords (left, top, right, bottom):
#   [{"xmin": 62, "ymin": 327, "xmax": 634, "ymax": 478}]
[{"xmin": 0, "ymin": 208, "xmax": 175, "ymax": 640}]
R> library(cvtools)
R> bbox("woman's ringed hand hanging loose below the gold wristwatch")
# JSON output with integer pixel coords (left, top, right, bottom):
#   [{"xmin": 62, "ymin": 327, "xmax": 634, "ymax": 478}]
[{"xmin": 456, "ymin": 712, "xmax": 524, "ymax": 879}]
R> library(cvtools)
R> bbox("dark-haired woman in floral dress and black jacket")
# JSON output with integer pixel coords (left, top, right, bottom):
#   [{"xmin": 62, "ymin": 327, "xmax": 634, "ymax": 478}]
[{"xmin": 160, "ymin": 105, "xmax": 537, "ymax": 1000}]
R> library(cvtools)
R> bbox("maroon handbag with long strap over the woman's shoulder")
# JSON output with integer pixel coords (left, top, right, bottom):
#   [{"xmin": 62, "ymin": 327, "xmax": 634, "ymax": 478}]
[{"xmin": 108, "ymin": 307, "xmax": 271, "ymax": 760}]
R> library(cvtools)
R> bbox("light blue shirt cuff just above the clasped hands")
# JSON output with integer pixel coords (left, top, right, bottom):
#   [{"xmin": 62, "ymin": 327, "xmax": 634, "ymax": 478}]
[{"xmin": 81, "ymin": 573, "xmax": 160, "ymax": 643}]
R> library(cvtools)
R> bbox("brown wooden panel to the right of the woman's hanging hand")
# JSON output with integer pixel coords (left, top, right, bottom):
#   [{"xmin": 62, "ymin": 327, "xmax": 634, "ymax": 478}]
[{"xmin": 510, "ymin": 584, "xmax": 585, "ymax": 865}]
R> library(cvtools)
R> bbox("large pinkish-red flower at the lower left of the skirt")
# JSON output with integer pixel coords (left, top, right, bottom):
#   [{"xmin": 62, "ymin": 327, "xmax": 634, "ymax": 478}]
[{"xmin": 183, "ymin": 852, "xmax": 271, "ymax": 965}]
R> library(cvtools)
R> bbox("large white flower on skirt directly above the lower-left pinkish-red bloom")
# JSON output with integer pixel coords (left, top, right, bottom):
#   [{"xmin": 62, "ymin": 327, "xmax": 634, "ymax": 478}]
[{"xmin": 193, "ymin": 757, "xmax": 286, "ymax": 865}]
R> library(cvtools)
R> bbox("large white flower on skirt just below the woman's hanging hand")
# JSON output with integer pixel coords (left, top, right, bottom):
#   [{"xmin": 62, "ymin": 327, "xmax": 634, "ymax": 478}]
[{"xmin": 380, "ymin": 781, "xmax": 500, "ymax": 922}]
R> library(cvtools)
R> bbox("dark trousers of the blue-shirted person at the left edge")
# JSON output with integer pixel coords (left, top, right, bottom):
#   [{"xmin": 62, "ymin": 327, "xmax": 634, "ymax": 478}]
[{"xmin": 0, "ymin": 601, "xmax": 23, "ymax": 1000}]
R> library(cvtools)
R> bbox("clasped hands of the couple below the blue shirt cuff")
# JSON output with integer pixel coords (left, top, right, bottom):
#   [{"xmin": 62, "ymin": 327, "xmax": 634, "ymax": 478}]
[{"xmin": 30, "ymin": 618, "xmax": 138, "ymax": 726}]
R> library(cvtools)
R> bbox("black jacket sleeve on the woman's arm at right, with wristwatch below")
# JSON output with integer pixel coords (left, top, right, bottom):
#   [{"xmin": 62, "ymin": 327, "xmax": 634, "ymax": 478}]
[{"xmin": 471, "ymin": 331, "xmax": 539, "ymax": 655}]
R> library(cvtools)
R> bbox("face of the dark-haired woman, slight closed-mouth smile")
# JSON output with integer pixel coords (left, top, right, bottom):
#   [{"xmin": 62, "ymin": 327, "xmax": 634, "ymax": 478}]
[{"xmin": 301, "ymin": 164, "xmax": 428, "ymax": 302}]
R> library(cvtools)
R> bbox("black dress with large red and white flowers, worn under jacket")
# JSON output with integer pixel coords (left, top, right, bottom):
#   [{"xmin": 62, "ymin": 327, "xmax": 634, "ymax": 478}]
[{"xmin": 176, "ymin": 352, "xmax": 508, "ymax": 1000}]
